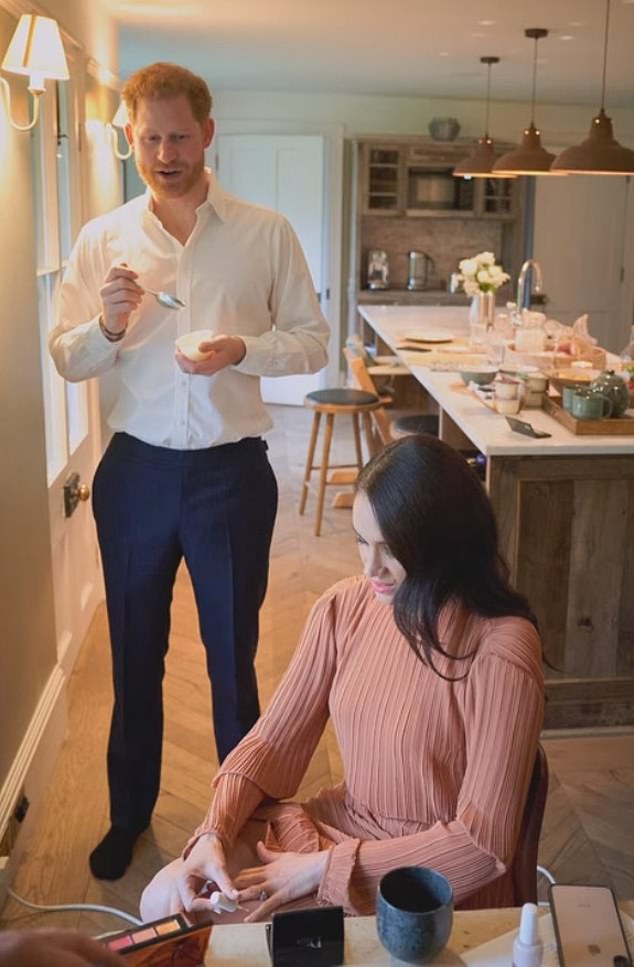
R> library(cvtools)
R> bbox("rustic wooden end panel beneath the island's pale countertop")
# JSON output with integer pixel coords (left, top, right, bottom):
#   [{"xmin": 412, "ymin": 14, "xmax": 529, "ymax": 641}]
[{"xmin": 487, "ymin": 455, "xmax": 634, "ymax": 728}]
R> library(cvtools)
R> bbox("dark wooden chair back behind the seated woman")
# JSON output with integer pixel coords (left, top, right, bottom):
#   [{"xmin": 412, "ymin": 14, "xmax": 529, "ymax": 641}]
[{"xmin": 511, "ymin": 744, "xmax": 548, "ymax": 907}]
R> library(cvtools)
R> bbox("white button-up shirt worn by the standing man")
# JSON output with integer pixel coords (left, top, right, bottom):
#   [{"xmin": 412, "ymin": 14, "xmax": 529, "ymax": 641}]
[{"xmin": 49, "ymin": 172, "xmax": 329, "ymax": 450}]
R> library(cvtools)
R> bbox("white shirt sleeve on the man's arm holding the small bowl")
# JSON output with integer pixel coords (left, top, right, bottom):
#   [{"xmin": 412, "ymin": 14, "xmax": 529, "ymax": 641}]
[{"xmin": 235, "ymin": 216, "xmax": 330, "ymax": 376}]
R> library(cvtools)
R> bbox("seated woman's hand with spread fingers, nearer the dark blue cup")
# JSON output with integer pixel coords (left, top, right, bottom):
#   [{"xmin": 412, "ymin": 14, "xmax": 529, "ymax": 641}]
[{"xmin": 235, "ymin": 843, "xmax": 328, "ymax": 923}]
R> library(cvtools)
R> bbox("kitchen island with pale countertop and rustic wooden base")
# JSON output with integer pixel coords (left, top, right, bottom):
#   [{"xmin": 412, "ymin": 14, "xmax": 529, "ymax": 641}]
[{"xmin": 359, "ymin": 305, "xmax": 634, "ymax": 728}]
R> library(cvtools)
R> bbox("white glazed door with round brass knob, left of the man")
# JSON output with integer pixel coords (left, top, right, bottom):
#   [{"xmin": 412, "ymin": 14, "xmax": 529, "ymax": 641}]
[{"xmin": 33, "ymin": 68, "xmax": 102, "ymax": 677}]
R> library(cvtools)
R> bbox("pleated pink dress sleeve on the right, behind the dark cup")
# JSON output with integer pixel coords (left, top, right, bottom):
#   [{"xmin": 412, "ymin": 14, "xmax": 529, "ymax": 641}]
[{"xmin": 318, "ymin": 622, "xmax": 544, "ymax": 914}]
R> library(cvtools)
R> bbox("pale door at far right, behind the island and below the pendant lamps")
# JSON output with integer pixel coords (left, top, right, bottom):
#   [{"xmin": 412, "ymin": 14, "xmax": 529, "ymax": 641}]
[{"xmin": 533, "ymin": 175, "xmax": 630, "ymax": 351}]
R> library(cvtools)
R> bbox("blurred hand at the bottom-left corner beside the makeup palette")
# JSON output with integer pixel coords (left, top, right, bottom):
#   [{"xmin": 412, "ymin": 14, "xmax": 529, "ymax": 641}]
[{"xmin": 0, "ymin": 930, "xmax": 125, "ymax": 967}]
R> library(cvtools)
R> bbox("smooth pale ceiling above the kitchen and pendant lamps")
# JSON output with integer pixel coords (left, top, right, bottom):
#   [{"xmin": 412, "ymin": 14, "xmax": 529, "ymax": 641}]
[{"xmin": 100, "ymin": 0, "xmax": 634, "ymax": 109}]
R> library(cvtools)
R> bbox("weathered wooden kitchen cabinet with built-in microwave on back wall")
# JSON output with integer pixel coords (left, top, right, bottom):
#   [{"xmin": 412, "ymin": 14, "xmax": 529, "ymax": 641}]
[{"xmin": 347, "ymin": 136, "xmax": 526, "ymax": 333}]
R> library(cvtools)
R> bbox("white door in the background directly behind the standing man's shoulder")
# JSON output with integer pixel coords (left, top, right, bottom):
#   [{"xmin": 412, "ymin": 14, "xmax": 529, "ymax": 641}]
[{"xmin": 212, "ymin": 134, "xmax": 328, "ymax": 406}]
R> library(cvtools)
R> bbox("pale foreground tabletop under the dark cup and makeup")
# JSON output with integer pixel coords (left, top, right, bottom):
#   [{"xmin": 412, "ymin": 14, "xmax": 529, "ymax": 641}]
[{"xmin": 205, "ymin": 900, "xmax": 634, "ymax": 967}]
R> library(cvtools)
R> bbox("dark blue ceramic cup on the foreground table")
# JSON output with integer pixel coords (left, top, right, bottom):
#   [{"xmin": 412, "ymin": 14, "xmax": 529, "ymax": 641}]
[{"xmin": 376, "ymin": 866, "xmax": 453, "ymax": 964}]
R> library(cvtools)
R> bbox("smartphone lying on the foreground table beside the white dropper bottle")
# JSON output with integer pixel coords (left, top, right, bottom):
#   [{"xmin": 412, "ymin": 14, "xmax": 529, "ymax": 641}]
[{"xmin": 548, "ymin": 883, "xmax": 632, "ymax": 967}]
